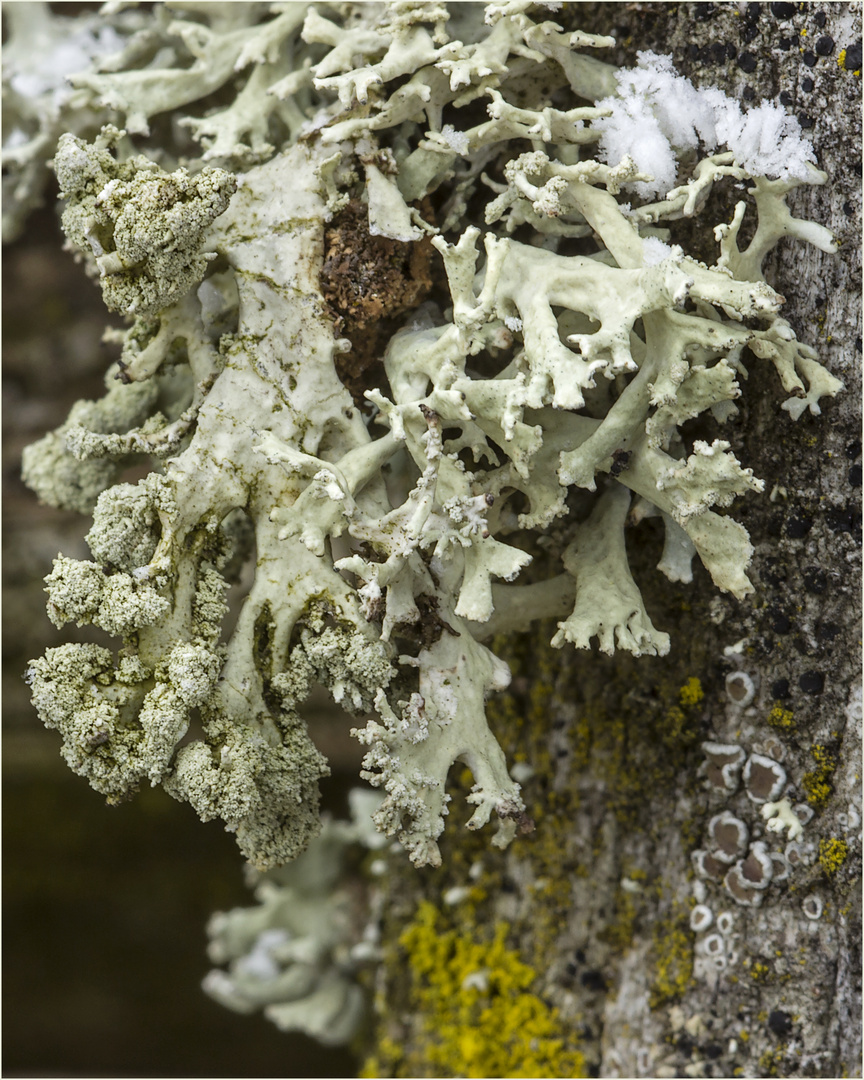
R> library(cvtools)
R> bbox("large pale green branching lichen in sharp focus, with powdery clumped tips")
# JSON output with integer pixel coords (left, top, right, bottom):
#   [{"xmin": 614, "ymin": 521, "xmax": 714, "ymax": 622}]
[{"xmin": 16, "ymin": 0, "xmax": 840, "ymax": 867}]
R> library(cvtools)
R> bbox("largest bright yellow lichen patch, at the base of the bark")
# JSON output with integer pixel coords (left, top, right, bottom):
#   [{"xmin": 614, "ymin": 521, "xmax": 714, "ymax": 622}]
[{"xmin": 361, "ymin": 902, "xmax": 586, "ymax": 1077}]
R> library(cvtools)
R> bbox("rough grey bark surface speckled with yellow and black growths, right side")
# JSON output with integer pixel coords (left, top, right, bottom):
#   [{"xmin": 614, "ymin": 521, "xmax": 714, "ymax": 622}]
[{"xmin": 366, "ymin": 3, "xmax": 861, "ymax": 1077}]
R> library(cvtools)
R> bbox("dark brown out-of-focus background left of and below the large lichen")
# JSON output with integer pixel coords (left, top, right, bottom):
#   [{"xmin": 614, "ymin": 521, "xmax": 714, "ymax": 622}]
[{"xmin": 2, "ymin": 200, "xmax": 362, "ymax": 1077}]
